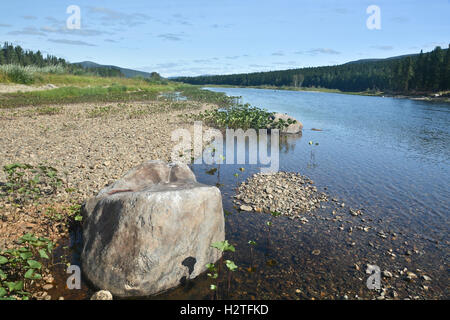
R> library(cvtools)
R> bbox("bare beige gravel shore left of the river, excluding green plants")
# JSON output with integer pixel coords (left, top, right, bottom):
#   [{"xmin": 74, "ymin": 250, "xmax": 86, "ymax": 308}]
[{"xmin": 0, "ymin": 101, "xmax": 214, "ymax": 249}]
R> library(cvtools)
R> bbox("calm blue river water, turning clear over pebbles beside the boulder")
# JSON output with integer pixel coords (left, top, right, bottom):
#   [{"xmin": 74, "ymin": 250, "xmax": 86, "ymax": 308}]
[{"xmin": 65, "ymin": 88, "xmax": 450, "ymax": 299}]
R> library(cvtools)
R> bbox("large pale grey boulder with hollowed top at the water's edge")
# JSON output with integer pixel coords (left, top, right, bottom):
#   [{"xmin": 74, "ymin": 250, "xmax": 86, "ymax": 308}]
[{"xmin": 81, "ymin": 161, "xmax": 225, "ymax": 297}]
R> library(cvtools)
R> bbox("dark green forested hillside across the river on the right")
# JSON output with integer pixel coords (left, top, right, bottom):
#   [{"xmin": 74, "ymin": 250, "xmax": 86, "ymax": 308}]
[{"xmin": 173, "ymin": 47, "xmax": 450, "ymax": 93}]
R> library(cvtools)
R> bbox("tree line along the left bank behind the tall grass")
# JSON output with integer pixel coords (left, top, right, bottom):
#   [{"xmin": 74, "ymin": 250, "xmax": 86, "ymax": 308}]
[{"xmin": 0, "ymin": 42, "xmax": 123, "ymax": 77}]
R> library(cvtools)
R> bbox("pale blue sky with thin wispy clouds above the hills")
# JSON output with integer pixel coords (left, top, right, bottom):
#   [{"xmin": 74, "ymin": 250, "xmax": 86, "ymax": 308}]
[{"xmin": 0, "ymin": 0, "xmax": 450, "ymax": 76}]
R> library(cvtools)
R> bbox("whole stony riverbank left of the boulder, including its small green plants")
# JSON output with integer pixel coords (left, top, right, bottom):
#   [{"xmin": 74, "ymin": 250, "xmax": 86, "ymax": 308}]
[{"xmin": 0, "ymin": 100, "xmax": 215, "ymax": 300}]
